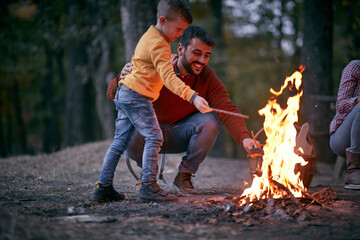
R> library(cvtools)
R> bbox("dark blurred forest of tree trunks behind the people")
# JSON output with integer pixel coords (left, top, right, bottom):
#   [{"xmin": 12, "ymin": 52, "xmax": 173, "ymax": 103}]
[{"xmin": 0, "ymin": 0, "xmax": 360, "ymax": 162}]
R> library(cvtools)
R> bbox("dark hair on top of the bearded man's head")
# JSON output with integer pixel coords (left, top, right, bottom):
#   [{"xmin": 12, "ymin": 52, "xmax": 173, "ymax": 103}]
[{"xmin": 179, "ymin": 26, "xmax": 216, "ymax": 50}]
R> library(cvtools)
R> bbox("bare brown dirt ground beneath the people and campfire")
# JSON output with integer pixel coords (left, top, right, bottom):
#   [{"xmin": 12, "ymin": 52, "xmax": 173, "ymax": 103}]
[{"xmin": 0, "ymin": 141, "xmax": 360, "ymax": 240}]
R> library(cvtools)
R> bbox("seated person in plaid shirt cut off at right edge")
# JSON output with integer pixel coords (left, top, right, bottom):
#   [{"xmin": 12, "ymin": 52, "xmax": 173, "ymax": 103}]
[{"xmin": 330, "ymin": 60, "xmax": 360, "ymax": 189}]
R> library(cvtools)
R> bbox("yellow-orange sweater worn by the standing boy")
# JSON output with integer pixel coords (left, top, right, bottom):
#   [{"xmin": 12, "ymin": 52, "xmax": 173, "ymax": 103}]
[{"xmin": 119, "ymin": 26, "xmax": 195, "ymax": 102}]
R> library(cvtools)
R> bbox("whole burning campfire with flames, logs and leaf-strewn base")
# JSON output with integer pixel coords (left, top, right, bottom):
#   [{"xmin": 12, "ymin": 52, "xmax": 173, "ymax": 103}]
[{"xmin": 194, "ymin": 68, "xmax": 337, "ymax": 226}]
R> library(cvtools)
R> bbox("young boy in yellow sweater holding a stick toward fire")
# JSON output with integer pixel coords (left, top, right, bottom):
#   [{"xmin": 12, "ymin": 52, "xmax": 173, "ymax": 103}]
[{"xmin": 93, "ymin": 0, "xmax": 210, "ymax": 202}]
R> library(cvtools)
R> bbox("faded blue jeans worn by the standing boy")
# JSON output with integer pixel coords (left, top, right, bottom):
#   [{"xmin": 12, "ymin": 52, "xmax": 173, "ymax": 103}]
[{"xmin": 99, "ymin": 86, "xmax": 163, "ymax": 186}]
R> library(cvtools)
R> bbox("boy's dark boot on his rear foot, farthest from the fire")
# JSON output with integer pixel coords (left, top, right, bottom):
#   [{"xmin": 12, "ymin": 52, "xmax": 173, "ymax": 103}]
[{"xmin": 92, "ymin": 182, "xmax": 125, "ymax": 203}]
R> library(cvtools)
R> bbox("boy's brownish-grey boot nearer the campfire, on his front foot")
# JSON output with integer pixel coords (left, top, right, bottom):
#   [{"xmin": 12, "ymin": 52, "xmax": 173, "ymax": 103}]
[{"xmin": 139, "ymin": 182, "xmax": 178, "ymax": 202}]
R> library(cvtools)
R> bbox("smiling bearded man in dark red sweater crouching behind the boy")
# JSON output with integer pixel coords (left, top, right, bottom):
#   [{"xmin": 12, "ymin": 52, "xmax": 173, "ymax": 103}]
[{"xmin": 120, "ymin": 26, "xmax": 256, "ymax": 194}]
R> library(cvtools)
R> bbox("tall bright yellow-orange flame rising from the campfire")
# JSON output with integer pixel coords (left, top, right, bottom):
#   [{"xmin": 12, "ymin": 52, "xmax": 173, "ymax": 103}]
[{"xmin": 240, "ymin": 68, "xmax": 307, "ymax": 205}]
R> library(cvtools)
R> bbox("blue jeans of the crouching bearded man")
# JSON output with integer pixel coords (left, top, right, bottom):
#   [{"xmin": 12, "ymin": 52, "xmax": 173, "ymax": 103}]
[{"xmin": 127, "ymin": 112, "xmax": 220, "ymax": 174}]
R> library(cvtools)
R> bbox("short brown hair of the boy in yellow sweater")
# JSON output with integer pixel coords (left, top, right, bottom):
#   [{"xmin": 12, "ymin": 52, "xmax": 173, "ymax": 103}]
[{"xmin": 157, "ymin": 0, "xmax": 193, "ymax": 24}]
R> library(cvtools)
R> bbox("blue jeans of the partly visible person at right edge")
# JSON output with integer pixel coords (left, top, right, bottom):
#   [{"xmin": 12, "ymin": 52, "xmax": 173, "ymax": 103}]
[{"xmin": 330, "ymin": 103, "xmax": 360, "ymax": 157}]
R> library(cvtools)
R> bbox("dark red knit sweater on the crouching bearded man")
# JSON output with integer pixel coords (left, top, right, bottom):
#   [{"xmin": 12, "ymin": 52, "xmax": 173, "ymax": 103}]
[{"xmin": 153, "ymin": 66, "xmax": 250, "ymax": 145}]
